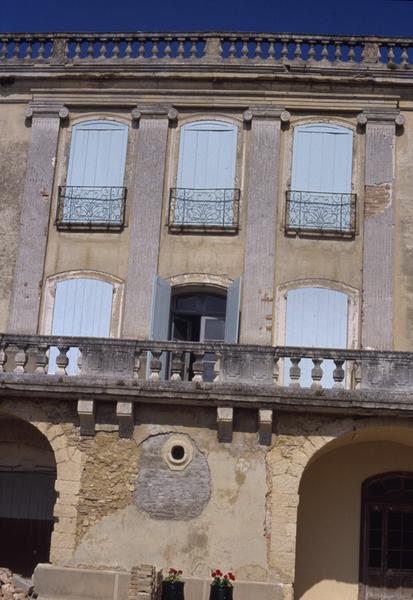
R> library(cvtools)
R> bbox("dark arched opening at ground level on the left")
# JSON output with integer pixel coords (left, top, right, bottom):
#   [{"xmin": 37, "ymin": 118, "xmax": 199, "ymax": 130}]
[{"xmin": 0, "ymin": 416, "xmax": 56, "ymax": 577}]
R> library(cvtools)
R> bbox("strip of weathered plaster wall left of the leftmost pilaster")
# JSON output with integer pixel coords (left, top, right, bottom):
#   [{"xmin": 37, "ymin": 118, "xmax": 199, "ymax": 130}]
[{"xmin": 0, "ymin": 103, "xmax": 30, "ymax": 331}]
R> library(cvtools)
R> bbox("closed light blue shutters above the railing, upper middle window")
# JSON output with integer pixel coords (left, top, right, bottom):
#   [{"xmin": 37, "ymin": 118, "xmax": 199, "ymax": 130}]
[{"xmin": 177, "ymin": 121, "xmax": 237, "ymax": 189}]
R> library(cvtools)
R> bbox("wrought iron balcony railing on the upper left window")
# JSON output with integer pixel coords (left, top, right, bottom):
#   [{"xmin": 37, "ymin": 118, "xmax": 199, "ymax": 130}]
[{"xmin": 56, "ymin": 186, "xmax": 126, "ymax": 231}]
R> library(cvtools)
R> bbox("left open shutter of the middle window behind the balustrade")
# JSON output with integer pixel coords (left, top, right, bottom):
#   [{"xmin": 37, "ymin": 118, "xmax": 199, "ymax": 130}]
[{"xmin": 146, "ymin": 275, "xmax": 171, "ymax": 379}]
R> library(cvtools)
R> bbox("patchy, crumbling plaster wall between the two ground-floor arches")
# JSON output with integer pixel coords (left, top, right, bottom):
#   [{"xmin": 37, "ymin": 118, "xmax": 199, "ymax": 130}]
[{"xmin": 71, "ymin": 406, "xmax": 269, "ymax": 581}]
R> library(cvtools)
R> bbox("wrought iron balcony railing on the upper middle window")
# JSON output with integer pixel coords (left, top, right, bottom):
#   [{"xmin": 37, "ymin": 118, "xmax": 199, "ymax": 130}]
[{"xmin": 168, "ymin": 188, "xmax": 240, "ymax": 232}]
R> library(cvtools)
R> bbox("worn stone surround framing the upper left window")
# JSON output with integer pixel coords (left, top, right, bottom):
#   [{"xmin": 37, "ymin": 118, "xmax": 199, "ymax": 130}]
[{"xmin": 50, "ymin": 112, "xmax": 136, "ymax": 235}]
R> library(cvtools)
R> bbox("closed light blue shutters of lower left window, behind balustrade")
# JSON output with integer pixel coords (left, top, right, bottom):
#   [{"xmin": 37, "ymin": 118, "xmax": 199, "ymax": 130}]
[{"xmin": 49, "ymin": 278, "xmax": 113, "ymax": 375}]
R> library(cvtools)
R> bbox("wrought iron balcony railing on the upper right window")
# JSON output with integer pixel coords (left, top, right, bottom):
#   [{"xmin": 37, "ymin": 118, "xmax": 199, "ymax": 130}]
[{"xmin": 285, "ymin": 190, "xmax": 356, "ymax": 236}]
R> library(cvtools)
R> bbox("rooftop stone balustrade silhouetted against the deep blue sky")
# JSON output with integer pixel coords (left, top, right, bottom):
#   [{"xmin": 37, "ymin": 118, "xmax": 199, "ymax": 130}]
[{"xmin": 0, "ymin": 32, "xmax": 413, "ymax": 70}]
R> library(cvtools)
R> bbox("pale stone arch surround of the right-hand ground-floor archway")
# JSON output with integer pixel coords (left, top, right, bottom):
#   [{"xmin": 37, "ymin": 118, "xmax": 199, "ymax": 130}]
[{"xmin": 266, "ymin": 417, "xmax": 413, "ymax": 598}]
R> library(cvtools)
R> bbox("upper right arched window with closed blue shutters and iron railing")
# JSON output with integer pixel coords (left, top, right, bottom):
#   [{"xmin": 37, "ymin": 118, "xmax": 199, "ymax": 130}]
[{"xmin": 286, "ymin": 123, "xmax": 356, "ymax": 234}]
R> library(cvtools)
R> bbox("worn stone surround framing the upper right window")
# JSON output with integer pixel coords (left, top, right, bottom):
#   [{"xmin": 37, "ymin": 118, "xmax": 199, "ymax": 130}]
[{"xmin": 279, "ymin": 115, "xmax": 364, "ymax": 241}]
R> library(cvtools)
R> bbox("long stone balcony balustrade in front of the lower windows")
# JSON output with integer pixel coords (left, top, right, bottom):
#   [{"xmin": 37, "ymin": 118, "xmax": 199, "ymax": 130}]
[{"xmin": 0, "ymin": 334, "xmax": 413, "ymax": 392}]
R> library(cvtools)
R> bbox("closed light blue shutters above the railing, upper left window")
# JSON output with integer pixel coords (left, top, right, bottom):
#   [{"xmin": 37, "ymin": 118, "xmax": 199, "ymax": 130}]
[{"xmin": 66, "ymin": 120, "xmax": 128, "ymax": 187}]
